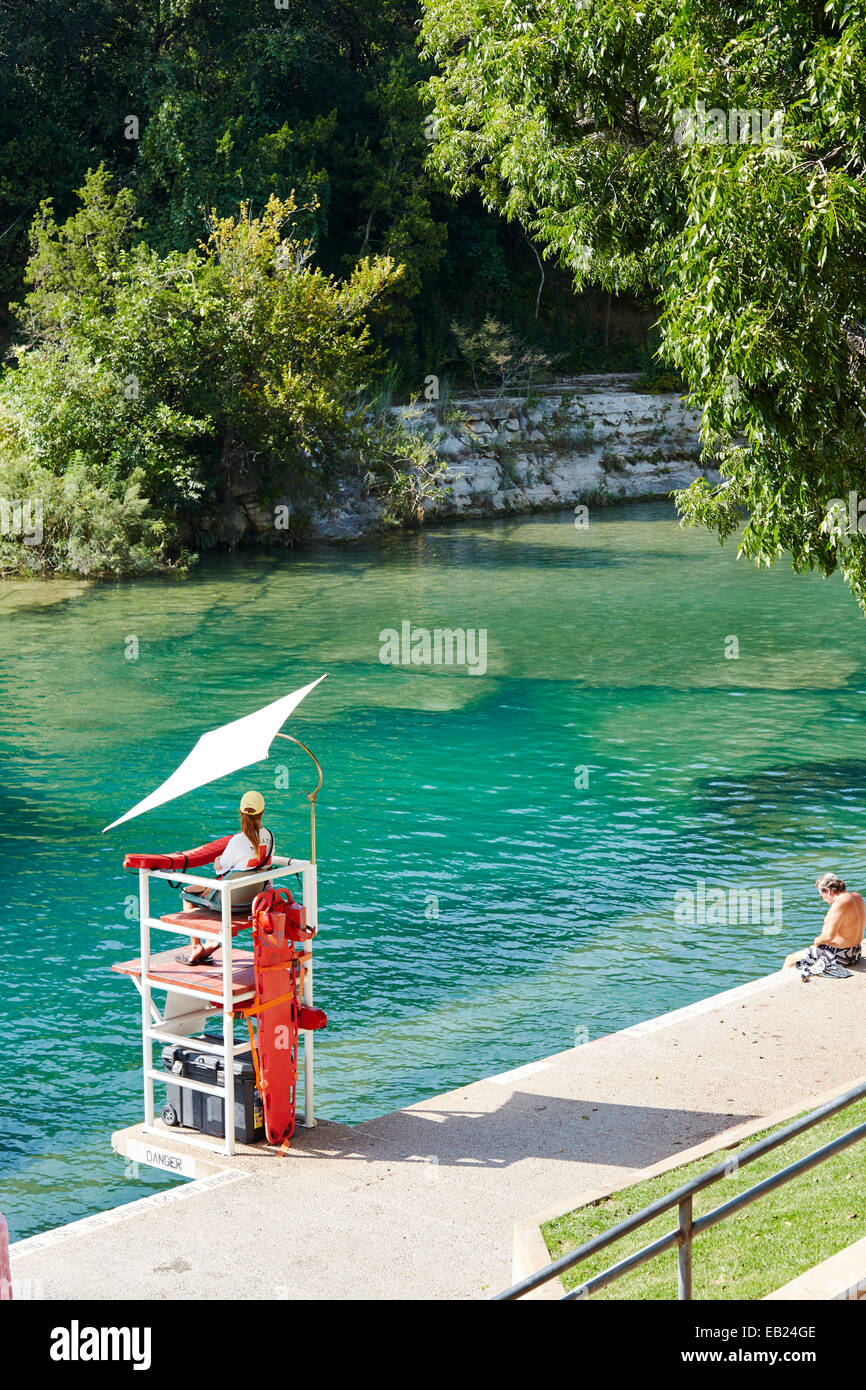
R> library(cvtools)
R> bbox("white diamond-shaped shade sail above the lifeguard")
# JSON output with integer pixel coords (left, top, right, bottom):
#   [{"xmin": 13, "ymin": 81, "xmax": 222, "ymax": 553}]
[{"xmin": 103, "ymin": 671, "xmax": 327, "ymax": 834}]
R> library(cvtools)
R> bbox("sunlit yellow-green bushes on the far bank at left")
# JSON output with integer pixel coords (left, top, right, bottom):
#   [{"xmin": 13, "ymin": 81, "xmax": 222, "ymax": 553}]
[{"xmin": 0, "ymin": 170, "xmax": 439, "ymax": 574}]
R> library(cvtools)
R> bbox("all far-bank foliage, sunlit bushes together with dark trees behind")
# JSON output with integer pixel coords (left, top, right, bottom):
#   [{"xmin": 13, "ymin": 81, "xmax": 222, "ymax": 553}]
[{"xmin": 0, "ymin": 0, "xmax": 648, "ymax": 574}]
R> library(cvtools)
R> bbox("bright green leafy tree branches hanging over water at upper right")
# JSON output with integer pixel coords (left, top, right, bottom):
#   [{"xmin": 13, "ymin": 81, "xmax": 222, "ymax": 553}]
[{"xmin": 424, "ymin": 0, "xmax": 866, "ymax": 605}]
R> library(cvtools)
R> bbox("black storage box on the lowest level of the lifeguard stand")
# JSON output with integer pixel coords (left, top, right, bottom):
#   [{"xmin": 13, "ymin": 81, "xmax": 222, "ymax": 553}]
[{"xmin": 163, "ymin": 1038, "xmax": 264, "ymax": 1144}]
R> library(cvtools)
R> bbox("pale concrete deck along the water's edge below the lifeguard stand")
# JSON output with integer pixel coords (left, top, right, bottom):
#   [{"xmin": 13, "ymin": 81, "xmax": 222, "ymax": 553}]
[{"xmin": 11, "ymin": 967, "xmax": 866, "ymax": 1300}]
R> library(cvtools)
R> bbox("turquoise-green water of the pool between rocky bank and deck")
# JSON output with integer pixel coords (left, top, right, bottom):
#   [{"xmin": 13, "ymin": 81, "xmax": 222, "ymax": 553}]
[{"xmin": 0, "ymin": 503, "xmax": 866, "ymax": 1238}]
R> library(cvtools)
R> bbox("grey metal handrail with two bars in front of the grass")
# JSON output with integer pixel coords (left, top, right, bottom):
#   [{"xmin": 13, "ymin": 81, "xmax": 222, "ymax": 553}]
[{"xmin": 492, "ymin": 1081, "xmax": 866, "ymax": 1302}]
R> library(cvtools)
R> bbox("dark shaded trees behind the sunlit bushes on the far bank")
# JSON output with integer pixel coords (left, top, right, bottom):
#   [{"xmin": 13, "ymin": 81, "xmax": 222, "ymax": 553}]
[{"xmin": 0, "ymin": 0, "xmax": 644, "ymax": 380}]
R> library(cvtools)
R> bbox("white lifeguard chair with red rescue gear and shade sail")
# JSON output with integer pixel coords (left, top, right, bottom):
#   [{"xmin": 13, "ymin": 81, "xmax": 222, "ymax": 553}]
[{"xmin": 108, "ymin": 677, "xmax": 327, "ymax": 1155}]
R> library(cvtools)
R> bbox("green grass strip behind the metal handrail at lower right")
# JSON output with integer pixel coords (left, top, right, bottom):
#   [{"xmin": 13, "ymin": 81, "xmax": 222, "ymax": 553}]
[{"xmin": 541, "ymin": 1101, "xmax": 866, "ymax": 1300}]
